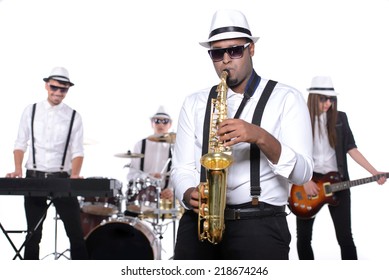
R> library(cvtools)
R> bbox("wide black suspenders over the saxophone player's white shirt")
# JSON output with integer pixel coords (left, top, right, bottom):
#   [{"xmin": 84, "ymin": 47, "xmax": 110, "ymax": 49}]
[{"xmin": 200, "ymin": 77, "xmax": 277, "ymax": 204}]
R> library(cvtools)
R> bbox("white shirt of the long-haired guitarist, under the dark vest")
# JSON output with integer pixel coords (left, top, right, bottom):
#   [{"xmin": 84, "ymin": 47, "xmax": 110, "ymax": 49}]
[{"xmin": 313, "ymin": 113, "xmax": 338, "ymax": 174}]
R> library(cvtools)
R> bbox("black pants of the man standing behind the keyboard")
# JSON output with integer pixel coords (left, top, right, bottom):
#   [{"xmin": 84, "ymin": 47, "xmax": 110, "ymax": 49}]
[{"xmin": 24, "ymin": 172, "xmax": 89, "ymax": 260}]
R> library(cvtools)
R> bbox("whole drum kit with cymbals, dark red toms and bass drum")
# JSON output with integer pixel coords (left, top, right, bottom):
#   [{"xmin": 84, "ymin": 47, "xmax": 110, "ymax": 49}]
[{"xmin": 79, "ymin": 133, "xmax": 184, "ymax": 260}]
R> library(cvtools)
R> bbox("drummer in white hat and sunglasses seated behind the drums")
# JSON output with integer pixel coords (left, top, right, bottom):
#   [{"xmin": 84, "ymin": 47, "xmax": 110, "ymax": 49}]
[{"xmin": 131, "ymin": 106, "xmax": 174, "ymax": 200}]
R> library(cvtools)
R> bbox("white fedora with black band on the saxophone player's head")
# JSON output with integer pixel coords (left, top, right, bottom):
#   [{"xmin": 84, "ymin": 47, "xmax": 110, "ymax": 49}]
[{"xmin": 200, "ymin": 10, "xmax": 259, "ymax": 48}]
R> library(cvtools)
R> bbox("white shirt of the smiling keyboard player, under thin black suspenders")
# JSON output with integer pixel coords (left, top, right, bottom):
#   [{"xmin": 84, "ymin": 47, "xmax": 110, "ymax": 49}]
[{"xmin": 14, "ymin": 100, "xmax": 84, "ymax": 173}]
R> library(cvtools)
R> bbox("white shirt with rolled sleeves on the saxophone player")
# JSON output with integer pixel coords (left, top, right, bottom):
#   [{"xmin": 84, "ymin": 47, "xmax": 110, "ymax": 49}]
[{"xmin": 171, "ymin": 79, "xmax": 313, "ymax": 205}]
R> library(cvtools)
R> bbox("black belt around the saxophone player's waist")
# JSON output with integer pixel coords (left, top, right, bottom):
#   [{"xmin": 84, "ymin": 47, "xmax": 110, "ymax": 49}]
[{"xmin": 224, "ymin": 202, "xmax": 286, "ymax": 220}]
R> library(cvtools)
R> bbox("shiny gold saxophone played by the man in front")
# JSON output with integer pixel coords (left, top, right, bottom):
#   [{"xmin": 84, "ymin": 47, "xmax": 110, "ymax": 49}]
[{"xmin": 198, "ymin": 71, "xmax": 233, "ymax": 244}]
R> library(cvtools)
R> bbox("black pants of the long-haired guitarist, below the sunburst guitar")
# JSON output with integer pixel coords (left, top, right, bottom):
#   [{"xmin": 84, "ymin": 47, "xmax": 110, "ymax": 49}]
[{"xmin": 296, "ymin": 190, "xmax": 357, "ymax": 260}]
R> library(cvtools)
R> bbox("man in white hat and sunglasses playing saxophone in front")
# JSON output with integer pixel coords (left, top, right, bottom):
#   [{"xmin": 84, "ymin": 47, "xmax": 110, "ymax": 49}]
[{"xmin": 171, "ymin": 10, "xmax": 313, "ymax": 260}]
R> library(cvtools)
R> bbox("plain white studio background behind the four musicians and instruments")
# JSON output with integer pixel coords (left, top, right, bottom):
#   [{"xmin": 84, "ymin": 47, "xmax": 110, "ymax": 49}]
[{"xmin": 0, "ymin": 0, "xmax": 389, "ymax": 266}]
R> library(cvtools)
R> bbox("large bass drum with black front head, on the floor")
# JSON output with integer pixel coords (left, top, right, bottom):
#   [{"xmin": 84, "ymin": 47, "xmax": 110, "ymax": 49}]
[{"xmin": 85, "ymin": 217, "xmax": 160, "ymax": 260}]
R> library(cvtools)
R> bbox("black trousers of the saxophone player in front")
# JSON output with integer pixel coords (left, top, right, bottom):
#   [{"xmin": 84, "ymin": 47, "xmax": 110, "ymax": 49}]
[{"xmin": 174, "ymin": 211, "xmax": 291, "ymax": 260}]
